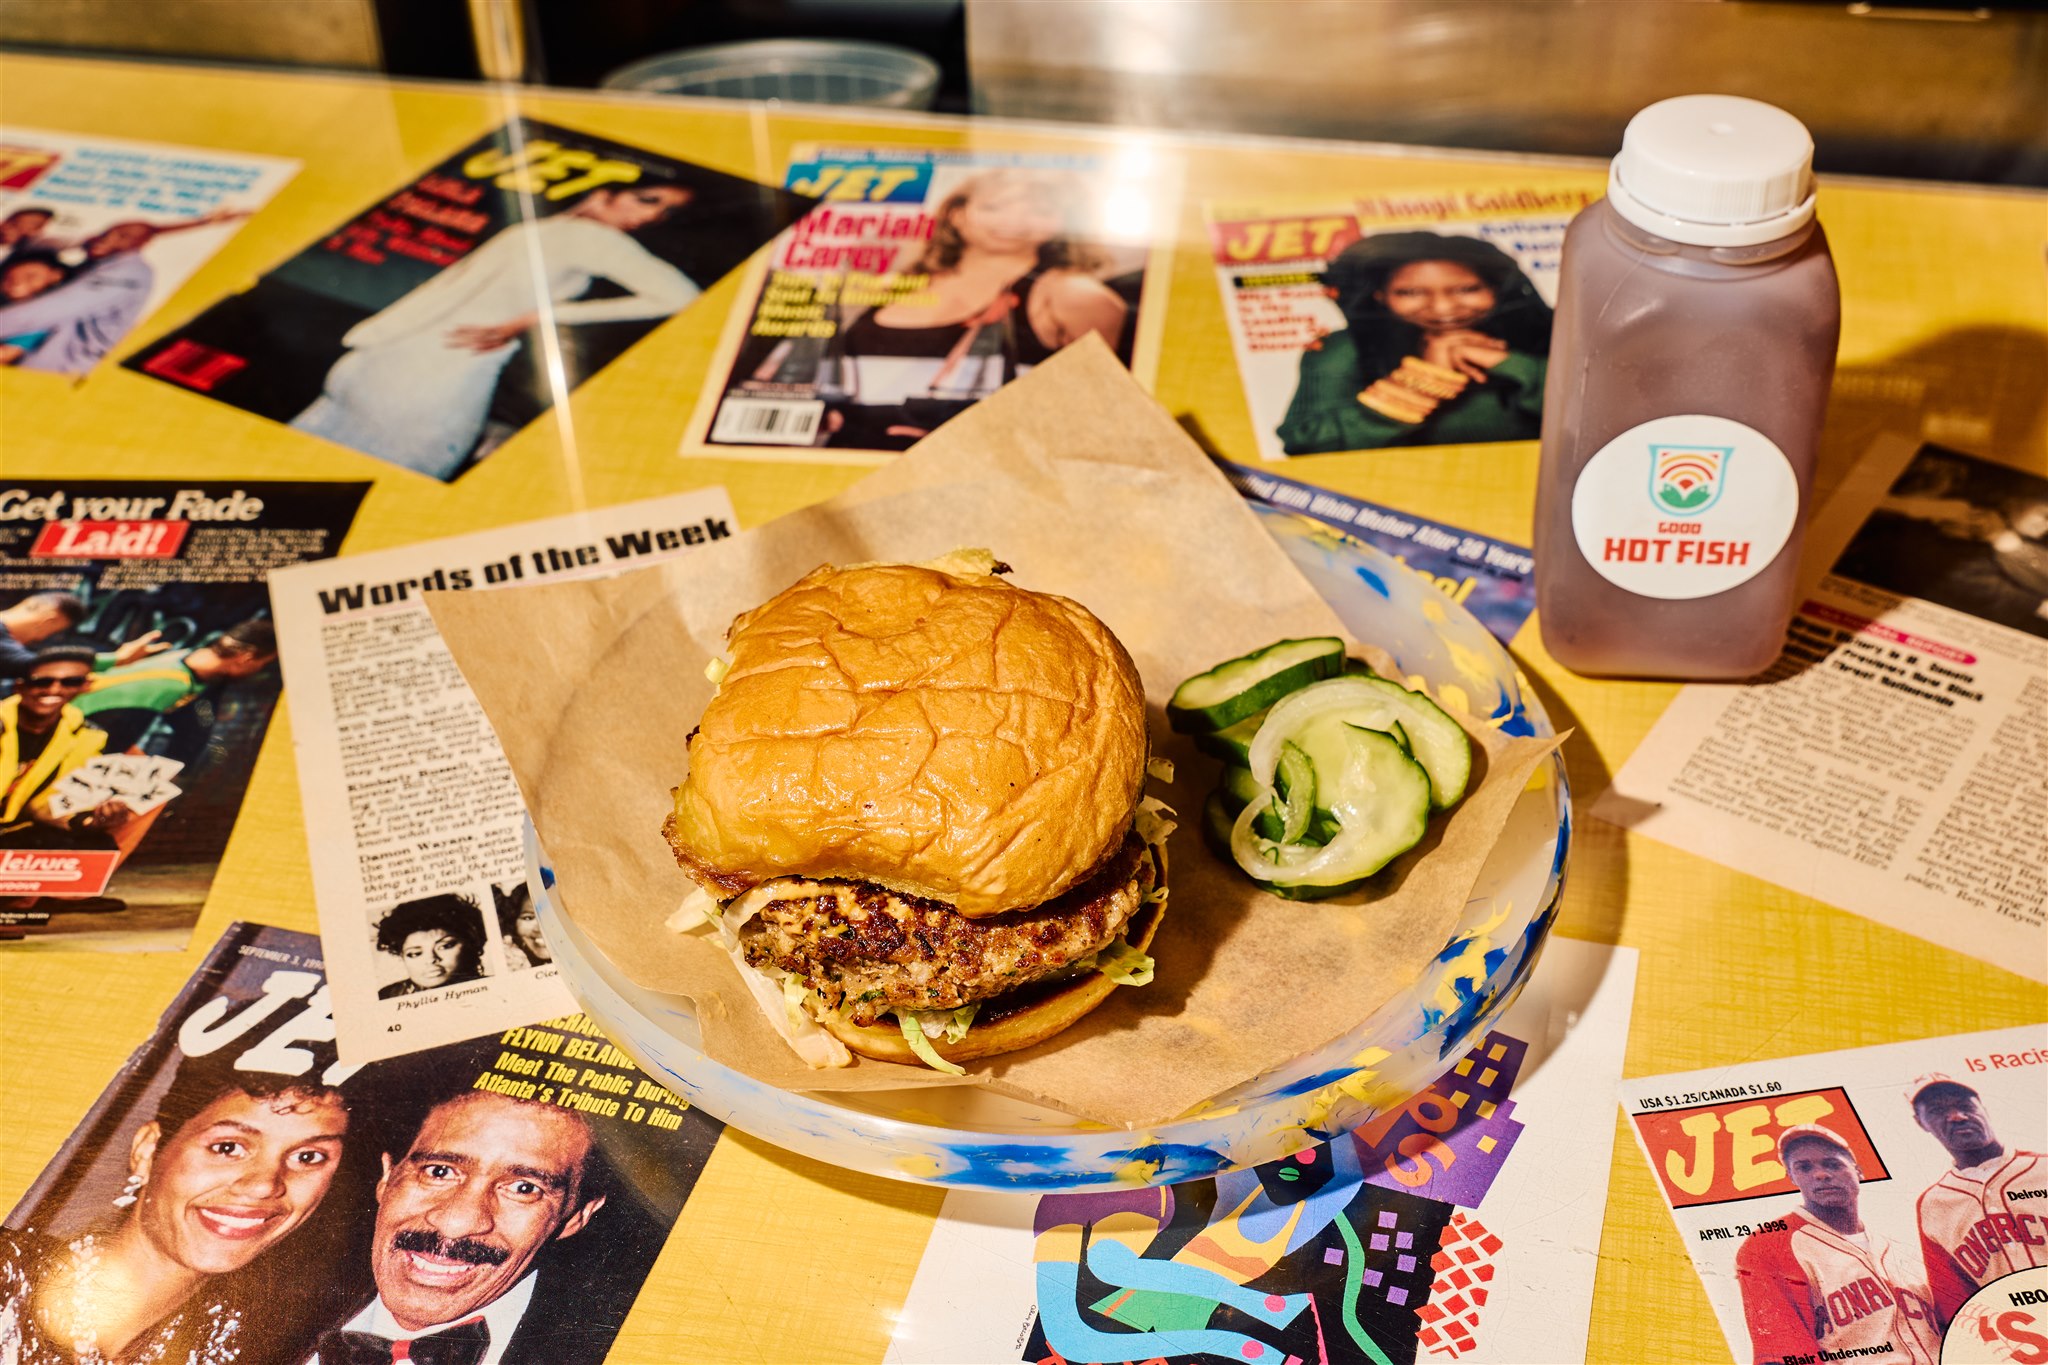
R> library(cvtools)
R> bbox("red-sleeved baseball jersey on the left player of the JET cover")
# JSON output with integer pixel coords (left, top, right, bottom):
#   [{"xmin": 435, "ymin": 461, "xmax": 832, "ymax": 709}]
[{"xmin": 1735, "ymin": 1212, "xmax": 1942, "ymax": 1365}]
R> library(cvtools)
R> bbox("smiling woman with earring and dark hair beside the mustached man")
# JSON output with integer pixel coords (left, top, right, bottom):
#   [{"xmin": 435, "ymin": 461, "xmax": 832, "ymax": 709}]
[{"xmin": 0, "ymin": 1056, "xmax": 348, "ymax": 1365}]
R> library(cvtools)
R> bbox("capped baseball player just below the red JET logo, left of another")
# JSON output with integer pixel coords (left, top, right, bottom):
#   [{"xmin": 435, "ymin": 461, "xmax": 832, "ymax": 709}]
[{"xmin": 1735, "ymin": 1124, "xmax": 1942, "ymax": 1365}]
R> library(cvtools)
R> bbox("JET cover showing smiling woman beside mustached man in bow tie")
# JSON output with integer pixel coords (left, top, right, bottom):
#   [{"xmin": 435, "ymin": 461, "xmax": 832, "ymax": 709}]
[{"xmin": 0, "ymin": 923, "xmax": 719, "ymax": 1365}]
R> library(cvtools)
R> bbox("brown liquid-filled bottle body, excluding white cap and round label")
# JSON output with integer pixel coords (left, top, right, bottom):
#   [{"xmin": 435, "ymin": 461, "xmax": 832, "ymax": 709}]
[{"xmin": 1536, "ymin": 201, "xmax": 1841, "ymax": 679}]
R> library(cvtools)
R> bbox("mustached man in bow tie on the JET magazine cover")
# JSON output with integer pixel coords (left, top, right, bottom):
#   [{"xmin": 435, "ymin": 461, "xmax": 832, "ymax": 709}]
[{"xmin": 307, "ymin": 1091, "xmax": 610, "ymax": 1365}]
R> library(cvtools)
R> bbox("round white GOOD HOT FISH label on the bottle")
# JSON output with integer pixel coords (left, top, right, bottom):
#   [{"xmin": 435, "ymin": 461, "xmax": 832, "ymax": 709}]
[{"xmin": 1571, "ymin": 413, "xmax": 1798, "ymax": 602}]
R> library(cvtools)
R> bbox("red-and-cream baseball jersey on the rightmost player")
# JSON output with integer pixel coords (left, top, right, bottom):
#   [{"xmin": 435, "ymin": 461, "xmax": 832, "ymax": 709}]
[{"xmin": 1919, "ymin": 1152, "xmax": 2048, "ymax": 1322}]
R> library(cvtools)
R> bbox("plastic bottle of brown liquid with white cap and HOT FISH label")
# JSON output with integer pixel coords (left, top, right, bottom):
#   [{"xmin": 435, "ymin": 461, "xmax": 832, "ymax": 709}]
[{"xmin": 1536, "ymin": 94, "xmax": 1841, "ymax": 679}]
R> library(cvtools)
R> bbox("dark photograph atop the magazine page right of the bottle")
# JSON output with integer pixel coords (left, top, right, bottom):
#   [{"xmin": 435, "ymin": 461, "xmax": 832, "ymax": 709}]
[{"xmin": 1835, "ymin": 446, "xmax": 2048, "ymax": 639}]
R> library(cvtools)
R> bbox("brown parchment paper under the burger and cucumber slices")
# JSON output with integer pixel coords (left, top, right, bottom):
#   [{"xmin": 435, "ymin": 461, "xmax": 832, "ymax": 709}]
[{"xmin": 428, "ymin": 344, "xmax": 1554, "ymax": 1128}]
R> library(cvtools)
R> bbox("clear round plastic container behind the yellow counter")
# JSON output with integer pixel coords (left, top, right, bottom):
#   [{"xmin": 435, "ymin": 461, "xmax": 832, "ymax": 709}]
[{"xmin": 602, "ymin": 39, "xmax": 940, "ymax": 108}]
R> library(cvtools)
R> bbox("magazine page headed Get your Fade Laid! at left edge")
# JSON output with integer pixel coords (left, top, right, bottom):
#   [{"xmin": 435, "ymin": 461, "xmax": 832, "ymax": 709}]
[{"xmin": 0, "ymin": 479, "xmax": 369, "ymax": 952}]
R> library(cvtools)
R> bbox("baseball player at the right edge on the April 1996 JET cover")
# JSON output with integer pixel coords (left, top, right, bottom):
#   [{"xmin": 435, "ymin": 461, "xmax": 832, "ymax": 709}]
[{"xmin": 1907, "ymin": 1072, "xmax": 2048, "ymax": 1322}]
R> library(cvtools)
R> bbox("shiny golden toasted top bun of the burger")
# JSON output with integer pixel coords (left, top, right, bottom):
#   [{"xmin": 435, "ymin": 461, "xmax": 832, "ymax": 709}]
[{"xmin": 668, "ymin": 565, "xmax": 1147, "ymax": 915}]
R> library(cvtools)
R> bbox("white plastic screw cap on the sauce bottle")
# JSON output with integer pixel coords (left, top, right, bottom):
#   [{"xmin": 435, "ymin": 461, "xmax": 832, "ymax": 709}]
[{"xmin": 1608, "ymin": 94, "xmax": 1812, "ymax": 246}]
